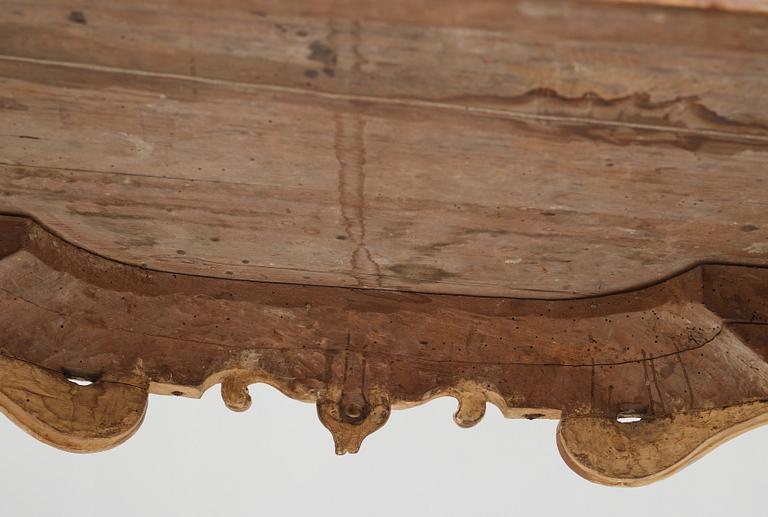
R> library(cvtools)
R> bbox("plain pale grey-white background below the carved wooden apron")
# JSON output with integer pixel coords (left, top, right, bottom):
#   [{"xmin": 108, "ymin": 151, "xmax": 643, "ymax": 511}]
[{"xmin": 0, "ymin": 385, "xmax": 768, "ymax": 517}]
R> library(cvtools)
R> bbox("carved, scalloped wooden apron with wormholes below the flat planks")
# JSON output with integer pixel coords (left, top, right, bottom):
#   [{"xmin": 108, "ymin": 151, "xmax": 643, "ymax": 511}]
[{"xmin": 0, "ymin": 216, "xmax": 768, "ymax": 485}]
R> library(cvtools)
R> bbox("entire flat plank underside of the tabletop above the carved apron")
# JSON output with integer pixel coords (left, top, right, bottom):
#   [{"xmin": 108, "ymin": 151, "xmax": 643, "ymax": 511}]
[{"xmin": 0, "ymin": 0, "xmax": 768, "ymax": 298}]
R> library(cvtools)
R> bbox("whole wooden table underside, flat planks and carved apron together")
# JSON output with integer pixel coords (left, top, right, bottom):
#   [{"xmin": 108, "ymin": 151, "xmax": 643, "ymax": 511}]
[{"xmin": 0, "ymin": 0, "xmax": 768, "ymax": 485}]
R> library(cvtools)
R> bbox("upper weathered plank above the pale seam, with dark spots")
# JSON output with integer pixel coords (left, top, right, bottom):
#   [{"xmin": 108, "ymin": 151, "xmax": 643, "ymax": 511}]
[{"xmin": 0, "ymin": 0, "xmax": 768, "ymax": 127}]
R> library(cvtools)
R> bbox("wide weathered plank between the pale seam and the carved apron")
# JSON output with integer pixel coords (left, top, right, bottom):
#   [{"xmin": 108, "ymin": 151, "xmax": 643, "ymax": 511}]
[{"xmin": 0, "ymin": 55, "xmax": 768, "ymax": 297}]
